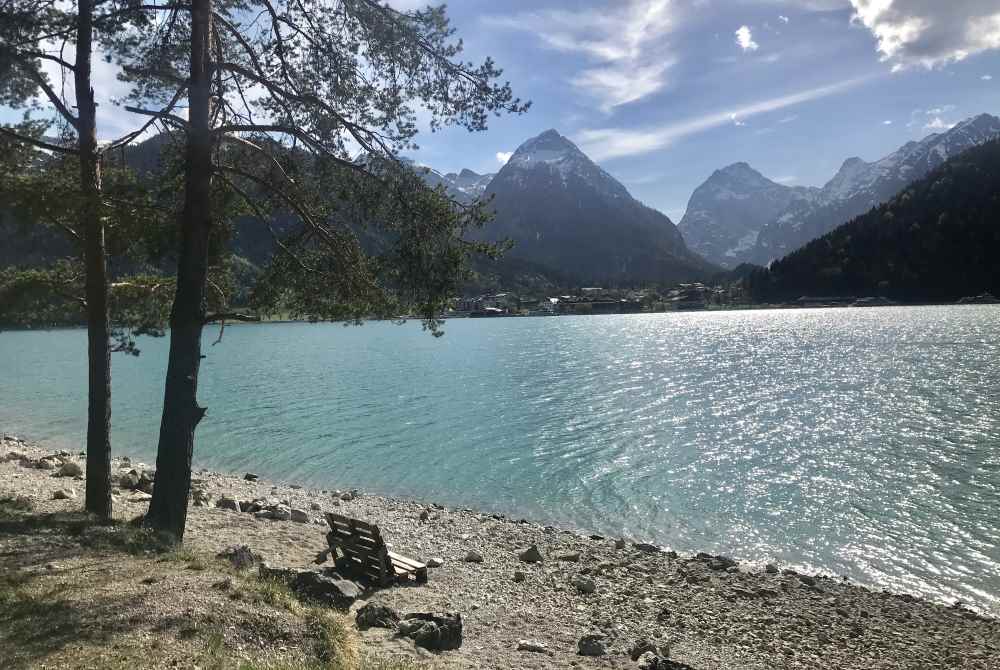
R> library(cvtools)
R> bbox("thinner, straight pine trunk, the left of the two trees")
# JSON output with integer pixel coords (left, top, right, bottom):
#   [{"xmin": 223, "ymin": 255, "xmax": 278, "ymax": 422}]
[{"xmin": 74, "ymin": 0, "xmax": 111, "ymax": 519}]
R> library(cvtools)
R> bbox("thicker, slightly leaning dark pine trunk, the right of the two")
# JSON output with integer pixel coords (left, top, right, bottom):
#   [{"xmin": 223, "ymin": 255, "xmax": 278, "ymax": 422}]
[{"xmin": 145, "ymin": 0, "xmax": 212, "ymax": 541}]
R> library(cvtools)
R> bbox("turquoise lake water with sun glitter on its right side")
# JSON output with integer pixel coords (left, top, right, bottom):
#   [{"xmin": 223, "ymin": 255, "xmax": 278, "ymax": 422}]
[{"xmin": 0, "ymin": 306, "xmax": 1000, "ymax": 611}]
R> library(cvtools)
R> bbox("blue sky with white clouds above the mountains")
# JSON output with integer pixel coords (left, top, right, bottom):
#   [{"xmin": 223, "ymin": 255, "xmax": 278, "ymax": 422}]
[{"xmin": 7, "ymin": 0, "xmax": 1000, "ymax": 222}]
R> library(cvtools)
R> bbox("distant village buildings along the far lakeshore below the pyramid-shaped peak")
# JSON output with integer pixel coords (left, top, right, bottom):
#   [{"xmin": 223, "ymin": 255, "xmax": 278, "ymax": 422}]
[{"xmin": 445, "ymin": 282, "xmax": 749, "ymax": 318}]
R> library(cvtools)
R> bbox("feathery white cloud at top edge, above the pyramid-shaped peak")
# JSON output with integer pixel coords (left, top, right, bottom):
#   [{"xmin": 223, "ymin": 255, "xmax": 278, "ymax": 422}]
[{"xmin": 483, "ymin": 0, "xmax": 676, "ymax": 112}]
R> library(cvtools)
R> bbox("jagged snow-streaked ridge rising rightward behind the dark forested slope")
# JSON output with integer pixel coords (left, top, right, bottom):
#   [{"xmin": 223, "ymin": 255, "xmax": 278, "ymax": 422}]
[{"xmin": 744, "ymin": 114, "xmax": 1000, "ymax": 264}]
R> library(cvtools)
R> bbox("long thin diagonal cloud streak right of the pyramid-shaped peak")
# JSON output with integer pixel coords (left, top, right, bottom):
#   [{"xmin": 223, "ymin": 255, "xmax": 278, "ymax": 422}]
[{"xmin": 576, "ymin": 77, "xmax": 871, "ymax": 161}]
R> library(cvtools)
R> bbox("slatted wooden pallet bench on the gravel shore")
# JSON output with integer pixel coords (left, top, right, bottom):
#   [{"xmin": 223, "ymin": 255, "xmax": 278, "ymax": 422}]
[{"xmin": 321, "ymin": 513, "xmax": 427, "ymax": 586}]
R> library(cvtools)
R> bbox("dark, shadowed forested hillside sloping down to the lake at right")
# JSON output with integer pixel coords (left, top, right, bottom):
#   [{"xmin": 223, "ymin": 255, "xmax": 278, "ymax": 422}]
[{"xmin": 748, "ymin": 140, "xmax": 1000, "ymax": 302}]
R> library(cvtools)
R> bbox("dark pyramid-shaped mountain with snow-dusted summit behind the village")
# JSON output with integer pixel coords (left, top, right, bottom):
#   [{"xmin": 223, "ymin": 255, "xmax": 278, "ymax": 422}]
[{"xmin": 482, "ymin": 130, "xmax": 717, "ymax": 284}]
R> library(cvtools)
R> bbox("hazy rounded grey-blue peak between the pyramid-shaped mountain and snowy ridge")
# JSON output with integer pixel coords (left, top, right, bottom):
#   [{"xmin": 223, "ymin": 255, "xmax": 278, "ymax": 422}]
[{"xmin": 678, "ymin": 163, "xmax": 820, "ymax": 268}]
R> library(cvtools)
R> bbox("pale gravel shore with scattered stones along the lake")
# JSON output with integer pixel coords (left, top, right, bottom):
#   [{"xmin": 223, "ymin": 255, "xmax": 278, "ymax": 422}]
[{"xmin": 0, "ymin": 436, "xmax": 1000, "ymax": 670}]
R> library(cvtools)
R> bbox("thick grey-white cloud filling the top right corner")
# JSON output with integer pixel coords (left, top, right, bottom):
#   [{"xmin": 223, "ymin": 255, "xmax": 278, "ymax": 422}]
[{"xmin": 851, "ymin": 0, "xmax": 1000, "ymax": 68}]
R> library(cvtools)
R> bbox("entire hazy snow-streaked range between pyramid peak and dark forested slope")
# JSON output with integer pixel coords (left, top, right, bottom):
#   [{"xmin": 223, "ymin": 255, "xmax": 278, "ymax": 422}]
[{"xmin": 679, "ymin": 114, "xmax": 1000, "ymax": 268}]
